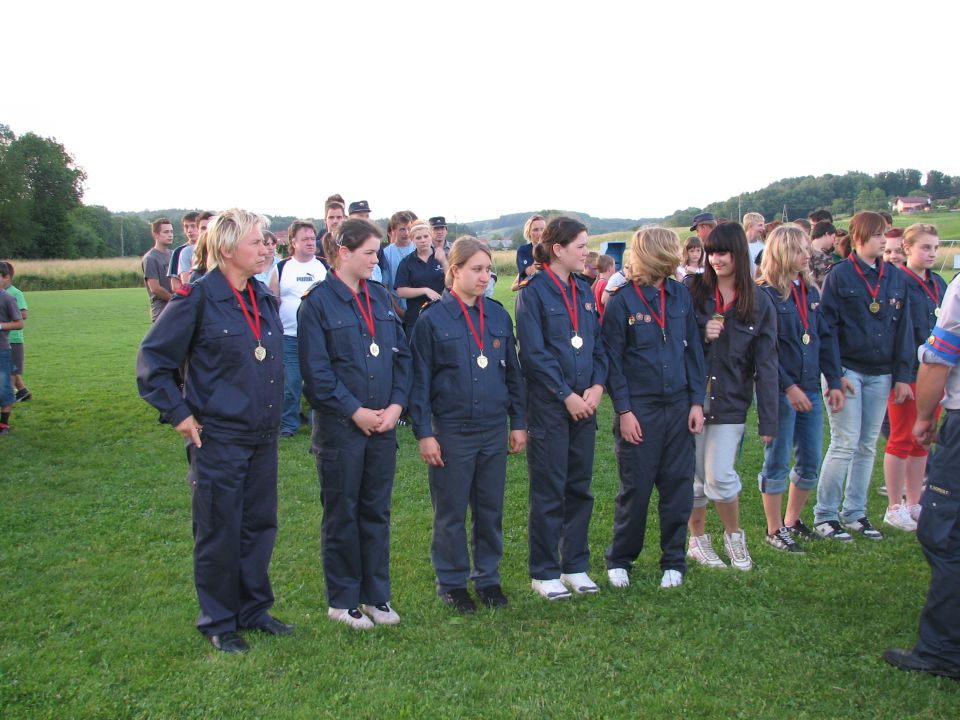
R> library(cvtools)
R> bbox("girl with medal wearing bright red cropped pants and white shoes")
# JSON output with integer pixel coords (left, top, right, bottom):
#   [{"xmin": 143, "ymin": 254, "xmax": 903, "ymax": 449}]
[{"xmin": 883, "ymin": 223, "xmax": 947, "ymax": 532}]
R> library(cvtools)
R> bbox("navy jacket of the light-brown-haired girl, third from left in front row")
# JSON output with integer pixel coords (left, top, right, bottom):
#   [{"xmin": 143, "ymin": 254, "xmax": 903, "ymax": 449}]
[{"xmin": 410, "ymin": 290, "xmax": 527, "ymax": 440}]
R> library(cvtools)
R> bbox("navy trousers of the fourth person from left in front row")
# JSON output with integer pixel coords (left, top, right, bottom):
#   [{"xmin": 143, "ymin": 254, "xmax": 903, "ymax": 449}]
[{"xmin": 527, "ymin": 387, "xmax": 597, "ymax": 580}]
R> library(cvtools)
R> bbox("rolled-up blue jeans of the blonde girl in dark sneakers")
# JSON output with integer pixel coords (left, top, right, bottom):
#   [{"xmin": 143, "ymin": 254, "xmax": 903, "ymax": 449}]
[{"xmin": 757, "ymin": 390, "xmax": 823, "ymax": 495}]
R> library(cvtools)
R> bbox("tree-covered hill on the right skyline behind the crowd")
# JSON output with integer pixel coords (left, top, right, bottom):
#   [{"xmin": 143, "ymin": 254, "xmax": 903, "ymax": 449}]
[{"xmin": 663, "ymin": 168, "xmax": 960, "ymax": 227}]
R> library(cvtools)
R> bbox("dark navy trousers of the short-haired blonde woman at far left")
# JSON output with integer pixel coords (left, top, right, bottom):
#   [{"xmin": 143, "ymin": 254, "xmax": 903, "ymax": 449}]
[{"xmin": 189, "ymin": 436, "xmax": 277, "ymax": 636}]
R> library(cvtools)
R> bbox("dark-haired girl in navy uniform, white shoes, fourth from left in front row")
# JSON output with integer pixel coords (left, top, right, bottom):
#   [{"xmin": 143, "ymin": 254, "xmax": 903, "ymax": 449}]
[{"xmin": 516, "ymin": 216, "xmax": 607, "ymax": 600}]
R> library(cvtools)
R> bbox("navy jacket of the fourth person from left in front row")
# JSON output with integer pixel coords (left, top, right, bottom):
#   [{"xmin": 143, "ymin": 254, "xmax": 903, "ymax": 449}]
[{"xmin": 516, "ymin": 271, "xmax": 608, "ymax": 402}]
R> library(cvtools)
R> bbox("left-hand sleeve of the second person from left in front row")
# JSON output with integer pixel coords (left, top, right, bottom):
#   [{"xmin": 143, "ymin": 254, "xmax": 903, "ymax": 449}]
[{"xmin": 297, "ymin": 291, "xmax": 363, "ymax": 417}]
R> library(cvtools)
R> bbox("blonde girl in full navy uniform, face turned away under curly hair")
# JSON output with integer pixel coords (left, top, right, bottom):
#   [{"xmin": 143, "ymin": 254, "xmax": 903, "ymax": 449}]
[{"xmin": 603, "ymin": 228, "xmax": 705, "ymax": 587}]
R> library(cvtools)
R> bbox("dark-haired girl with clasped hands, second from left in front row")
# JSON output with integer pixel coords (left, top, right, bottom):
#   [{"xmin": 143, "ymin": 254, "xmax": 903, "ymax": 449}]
[{"xmin": 297, "ymin": 219, "xmax": 412, "ymax": 630}]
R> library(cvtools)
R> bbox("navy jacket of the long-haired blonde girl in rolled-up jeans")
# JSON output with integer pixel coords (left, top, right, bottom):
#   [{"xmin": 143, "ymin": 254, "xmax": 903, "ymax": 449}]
[{"xmin": 760, "ymin": 283, "xmax": 841, "ymax": 393}]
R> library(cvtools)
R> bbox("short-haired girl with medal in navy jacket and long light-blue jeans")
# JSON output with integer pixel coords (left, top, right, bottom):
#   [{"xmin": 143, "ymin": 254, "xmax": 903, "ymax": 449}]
[{"xmin": 814, "ymin": 212, "xmax": 917, "ymax": 542}]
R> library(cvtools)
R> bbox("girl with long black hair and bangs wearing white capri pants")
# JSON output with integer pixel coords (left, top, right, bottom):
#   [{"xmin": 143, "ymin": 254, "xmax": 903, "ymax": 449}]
[{"xmin": 687, "ymin": 222, "xmax": 777, "ymax": 570}]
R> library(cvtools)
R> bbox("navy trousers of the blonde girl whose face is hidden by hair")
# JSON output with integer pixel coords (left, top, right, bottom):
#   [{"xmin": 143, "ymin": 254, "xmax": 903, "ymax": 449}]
[{"xmin": 606, "ymin": 399, "xmax": 695, "ymax": 573}]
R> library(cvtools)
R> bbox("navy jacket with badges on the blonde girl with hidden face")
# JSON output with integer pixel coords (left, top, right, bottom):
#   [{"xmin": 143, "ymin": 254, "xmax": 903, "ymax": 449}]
[{"xmin": 603, "ymin": 278, "xmax": 706, "ymax": 414}]
